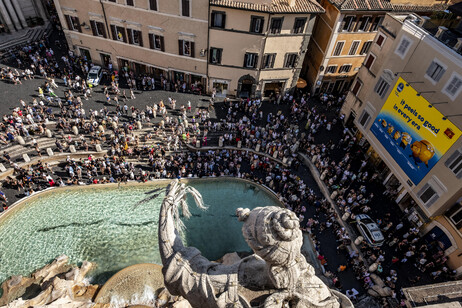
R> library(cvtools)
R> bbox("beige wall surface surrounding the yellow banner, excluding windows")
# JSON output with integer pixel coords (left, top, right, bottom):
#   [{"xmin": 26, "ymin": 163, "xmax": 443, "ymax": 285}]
[{"xmin": 348, "ymin": 15, "xmax": 462, "ymax": 217}]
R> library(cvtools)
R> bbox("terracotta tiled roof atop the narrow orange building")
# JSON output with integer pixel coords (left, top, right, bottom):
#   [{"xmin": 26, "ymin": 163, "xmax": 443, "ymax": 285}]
[{"xmin": 330, "ymin": 0, "xmax": 448, "ymax": 12}]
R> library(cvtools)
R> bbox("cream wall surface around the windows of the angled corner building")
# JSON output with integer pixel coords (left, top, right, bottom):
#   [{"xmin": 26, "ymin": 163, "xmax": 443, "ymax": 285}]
[{"xmin": 209, "ymin": 6, "xmax": 315, "ymax": 96}]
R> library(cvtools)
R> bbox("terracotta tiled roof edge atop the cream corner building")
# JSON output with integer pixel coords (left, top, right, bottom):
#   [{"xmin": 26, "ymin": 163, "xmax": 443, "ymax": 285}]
[{"xmin": 210, "ymin": 0, "xmax": 325, "ymax": 13}]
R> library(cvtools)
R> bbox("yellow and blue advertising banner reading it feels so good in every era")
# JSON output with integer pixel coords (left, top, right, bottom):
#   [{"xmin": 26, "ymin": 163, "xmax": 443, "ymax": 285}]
[{"xmin": 371, "ymin": 78, "xmax": 461, "ymax": 185}]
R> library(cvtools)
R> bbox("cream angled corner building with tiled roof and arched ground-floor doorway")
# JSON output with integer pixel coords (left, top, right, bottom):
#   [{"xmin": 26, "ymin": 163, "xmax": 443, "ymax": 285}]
[{"xmin": 208, "ymin": 0, "xmax": 324, "ymax": 97}]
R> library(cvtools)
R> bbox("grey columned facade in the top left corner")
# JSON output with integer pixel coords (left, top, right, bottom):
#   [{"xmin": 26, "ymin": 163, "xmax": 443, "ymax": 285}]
[{"xmin": 0, "ymin": 0, "xmax": 47, "ymax": 33}]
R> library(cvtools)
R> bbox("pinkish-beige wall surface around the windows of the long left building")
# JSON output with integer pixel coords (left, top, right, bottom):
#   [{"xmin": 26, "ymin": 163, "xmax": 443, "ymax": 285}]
[{"xmin": 57, "ymin": 0, "xmax": 208, "ymax": 77}]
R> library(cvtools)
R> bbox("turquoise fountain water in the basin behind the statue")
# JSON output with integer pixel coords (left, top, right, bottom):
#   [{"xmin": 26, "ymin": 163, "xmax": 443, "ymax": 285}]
[{"xmin": 0, "ymin": 179, "xmax": 278, "ymax": 283}]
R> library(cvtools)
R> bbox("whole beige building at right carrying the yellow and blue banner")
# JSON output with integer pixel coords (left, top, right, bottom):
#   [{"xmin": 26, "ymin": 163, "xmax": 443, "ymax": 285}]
[{"xmin": 342, "ymin": 14, "xmax": 462, "ymax": 274}]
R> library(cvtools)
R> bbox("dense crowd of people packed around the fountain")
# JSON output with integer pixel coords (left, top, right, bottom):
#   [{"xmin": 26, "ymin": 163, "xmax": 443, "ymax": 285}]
[{"xmin": 0, "ymin": 21, "xmax": 453, "ymax": 308}]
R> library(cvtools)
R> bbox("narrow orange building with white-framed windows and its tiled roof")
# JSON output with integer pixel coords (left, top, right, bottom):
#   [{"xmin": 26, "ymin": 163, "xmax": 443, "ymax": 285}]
[{"xmin": 302, "ymin": 0, "xmax": 448, "ymax": 94}]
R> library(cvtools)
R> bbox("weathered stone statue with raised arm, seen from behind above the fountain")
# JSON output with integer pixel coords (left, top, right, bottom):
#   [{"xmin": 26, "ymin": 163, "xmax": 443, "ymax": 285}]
[{"xmin": 159, "ymin": 180, "xmax": 350, "ymax": 308}]
